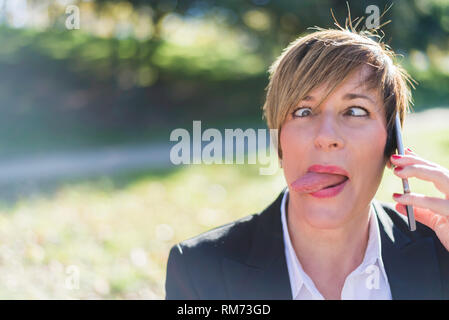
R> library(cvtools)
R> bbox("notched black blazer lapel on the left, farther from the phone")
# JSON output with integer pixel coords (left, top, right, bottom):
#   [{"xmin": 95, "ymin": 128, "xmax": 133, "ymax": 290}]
[{"xmin": 222, "ymin": 193, "xmax": 292, "ymax": 300}]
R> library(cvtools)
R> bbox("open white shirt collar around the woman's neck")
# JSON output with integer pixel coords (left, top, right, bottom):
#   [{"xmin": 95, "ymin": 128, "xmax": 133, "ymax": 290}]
[{"xmin": 281, "ymin": 188, "xmax": 386, "ymax": 299}]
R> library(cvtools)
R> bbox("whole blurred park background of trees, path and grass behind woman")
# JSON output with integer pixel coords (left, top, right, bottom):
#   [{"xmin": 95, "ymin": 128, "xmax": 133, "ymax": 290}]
[{"xmin": 0, "ymin": 0, "xmax": 449, "ymax": 299}]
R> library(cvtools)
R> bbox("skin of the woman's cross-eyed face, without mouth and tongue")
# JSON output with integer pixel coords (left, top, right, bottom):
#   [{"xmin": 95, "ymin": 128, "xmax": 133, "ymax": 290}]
[{"xmin": 280, "ymin": 67, "xmax": 387, "ymax": 228}]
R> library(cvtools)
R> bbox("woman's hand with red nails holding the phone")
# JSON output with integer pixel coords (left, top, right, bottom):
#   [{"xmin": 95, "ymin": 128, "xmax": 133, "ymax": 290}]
[{"xmin": 390, "ymin": 149, "xmax": 449, "ymax": 251}]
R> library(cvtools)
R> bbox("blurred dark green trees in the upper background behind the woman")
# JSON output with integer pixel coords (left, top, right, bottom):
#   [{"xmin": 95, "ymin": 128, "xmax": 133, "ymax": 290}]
[{"xmin": 0, "ymin": 0, "xmax": 449, "ymax": 155}]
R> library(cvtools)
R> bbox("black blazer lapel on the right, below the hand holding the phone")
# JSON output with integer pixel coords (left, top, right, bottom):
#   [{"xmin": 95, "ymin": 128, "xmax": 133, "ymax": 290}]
[{"xmin": 373, "ymin": 199, "xmax": 443, "ymax": 300}]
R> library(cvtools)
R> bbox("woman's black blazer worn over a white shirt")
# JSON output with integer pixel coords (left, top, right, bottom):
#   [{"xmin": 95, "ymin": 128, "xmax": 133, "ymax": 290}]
[{"xmin": 165, "ymin": 189, "xmax": 449, "ymax": 300}]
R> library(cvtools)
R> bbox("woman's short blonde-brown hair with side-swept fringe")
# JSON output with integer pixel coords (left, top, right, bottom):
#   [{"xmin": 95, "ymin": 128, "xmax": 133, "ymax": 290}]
[{"xmin": 263, "ymin": 28, "xmax": 415, "ymax": 158}]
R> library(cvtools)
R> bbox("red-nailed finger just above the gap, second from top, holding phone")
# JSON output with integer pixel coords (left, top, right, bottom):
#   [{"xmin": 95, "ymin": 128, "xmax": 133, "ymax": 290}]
[{"xmin": 393, "ymin": 164, "xmax": 449, "ymax": 198}]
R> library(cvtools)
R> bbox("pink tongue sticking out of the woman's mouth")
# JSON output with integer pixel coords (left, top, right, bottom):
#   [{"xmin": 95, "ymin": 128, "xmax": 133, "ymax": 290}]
[{"xmin": 291, "ymin": 172, "xmax": 347, "ymax": 193}]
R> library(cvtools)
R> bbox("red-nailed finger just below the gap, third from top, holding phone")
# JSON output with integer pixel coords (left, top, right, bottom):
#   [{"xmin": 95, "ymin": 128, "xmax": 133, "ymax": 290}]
[{"xmin": 393, "ymin": 192, "xmax": 449, "ymax": 216}]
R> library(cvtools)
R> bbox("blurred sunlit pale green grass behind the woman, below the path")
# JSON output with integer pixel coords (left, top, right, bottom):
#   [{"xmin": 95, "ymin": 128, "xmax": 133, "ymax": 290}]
[{"xmin": 0, "ymin": 124, "xmax": 449, "ymax": 299}]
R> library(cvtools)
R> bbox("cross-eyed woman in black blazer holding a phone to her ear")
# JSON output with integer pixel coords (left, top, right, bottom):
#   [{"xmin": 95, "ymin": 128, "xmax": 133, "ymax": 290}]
[{"xmin": 166, "ymin": 29, "xmax": 449, "ymax": 299}]
